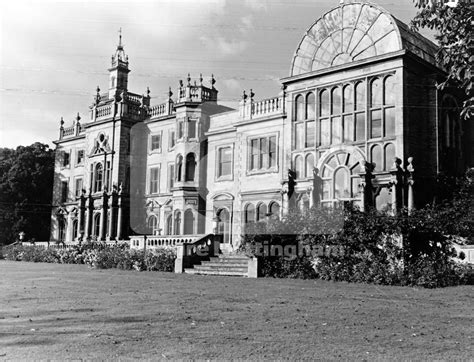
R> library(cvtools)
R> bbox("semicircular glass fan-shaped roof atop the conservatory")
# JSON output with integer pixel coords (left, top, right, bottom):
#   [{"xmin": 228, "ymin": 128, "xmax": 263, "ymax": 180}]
[{"xmin": 290, "ymin": 2, "xmax": 434, "ymax": 76}]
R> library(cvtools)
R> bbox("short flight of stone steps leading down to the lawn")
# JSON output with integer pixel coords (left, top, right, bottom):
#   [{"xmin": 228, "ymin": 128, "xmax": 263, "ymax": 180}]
[{"xmin": 184, "ymin": 254, "xmax": 249, "ymax": 277}]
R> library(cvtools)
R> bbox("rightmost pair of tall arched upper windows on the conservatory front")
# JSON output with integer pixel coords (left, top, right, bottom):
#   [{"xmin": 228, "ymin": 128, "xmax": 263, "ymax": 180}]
[{"xmin": 369, "ymin": 76, "xmax": 395, "ymax": 138}]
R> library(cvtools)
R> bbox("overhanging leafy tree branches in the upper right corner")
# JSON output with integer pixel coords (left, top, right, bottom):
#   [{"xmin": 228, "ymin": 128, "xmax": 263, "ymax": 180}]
[{"xmin": 411, "ymin": 0, "xmax": 474, "ymax": 119}]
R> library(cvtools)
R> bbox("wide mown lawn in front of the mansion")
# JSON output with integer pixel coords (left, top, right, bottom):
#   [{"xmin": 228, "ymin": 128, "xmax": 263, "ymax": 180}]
[{"xmin": 0, "ymin": 261, "xmax": 474, "ymax": 360}]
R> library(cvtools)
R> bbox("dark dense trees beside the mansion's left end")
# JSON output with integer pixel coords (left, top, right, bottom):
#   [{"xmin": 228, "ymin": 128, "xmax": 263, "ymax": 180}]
[{"xmin": 0, "ymin": 142, "xmax": 54, "ymax": 245}]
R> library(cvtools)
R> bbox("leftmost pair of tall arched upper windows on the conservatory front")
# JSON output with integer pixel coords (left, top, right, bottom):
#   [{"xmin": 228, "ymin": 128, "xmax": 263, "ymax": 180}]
[{"xmin": 293, "ymin": 92, "xmax": 316, "ymax": 150}]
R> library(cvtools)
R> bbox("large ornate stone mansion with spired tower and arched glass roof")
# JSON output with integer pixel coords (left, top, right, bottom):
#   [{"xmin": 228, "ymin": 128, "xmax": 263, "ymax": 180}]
[{"xmin": 51, "ymin": 1, "xmax": 474, "ymax": 248}]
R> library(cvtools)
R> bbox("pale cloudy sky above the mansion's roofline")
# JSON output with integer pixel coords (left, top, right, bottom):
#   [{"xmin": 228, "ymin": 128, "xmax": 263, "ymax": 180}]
[{"xmin": 0, "ymin": 0, "xmax": 434, "ymax": 147}]
